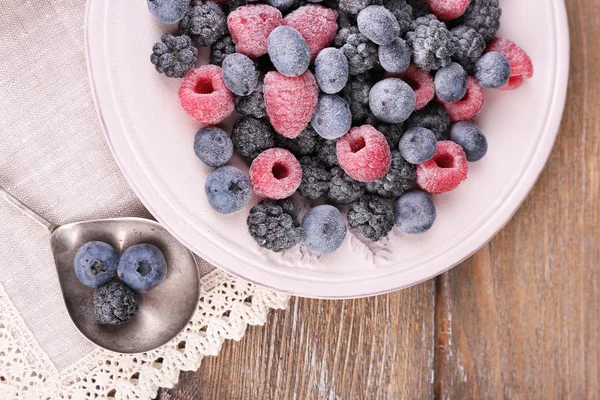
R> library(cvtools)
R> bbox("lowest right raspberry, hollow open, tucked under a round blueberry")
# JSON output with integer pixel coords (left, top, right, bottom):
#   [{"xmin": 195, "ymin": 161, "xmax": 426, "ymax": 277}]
[{"xmin": 417, "ymin": 140, "xmax": 469, "ymax": 194}]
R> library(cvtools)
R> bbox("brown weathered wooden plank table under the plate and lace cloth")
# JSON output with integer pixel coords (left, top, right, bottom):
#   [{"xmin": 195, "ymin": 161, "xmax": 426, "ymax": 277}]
[{"xmin": 159, "ymin": 0, "xmax": 600, "ymax": 400}]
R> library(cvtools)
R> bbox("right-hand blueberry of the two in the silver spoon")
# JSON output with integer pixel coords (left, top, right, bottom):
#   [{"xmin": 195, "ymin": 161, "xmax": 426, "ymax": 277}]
[{"xmin": 119, "ymin": 243, "xmax": 167, "ymax": 293}]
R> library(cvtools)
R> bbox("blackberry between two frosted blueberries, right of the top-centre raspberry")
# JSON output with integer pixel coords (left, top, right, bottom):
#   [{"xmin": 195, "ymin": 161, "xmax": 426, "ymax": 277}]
[{"xmin": 333, "ymin": 26, "xmax": 377, "ymax": 75}]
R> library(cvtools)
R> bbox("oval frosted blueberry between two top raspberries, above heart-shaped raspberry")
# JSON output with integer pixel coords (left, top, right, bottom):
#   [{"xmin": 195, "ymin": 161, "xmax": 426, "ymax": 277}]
[{"xmin": 268, "ymin": 26, "xmax": 310, "ymax": 77}]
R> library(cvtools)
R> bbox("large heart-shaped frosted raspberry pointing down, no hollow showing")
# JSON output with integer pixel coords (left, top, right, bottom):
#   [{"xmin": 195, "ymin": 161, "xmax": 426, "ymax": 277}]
[{"xmin": 264, "ymin": 71, "xmax": 319, "ymax": 139}]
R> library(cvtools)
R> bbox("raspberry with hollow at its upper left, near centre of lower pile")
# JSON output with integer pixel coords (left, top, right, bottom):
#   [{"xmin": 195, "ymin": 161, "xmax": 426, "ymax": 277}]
[{"xmin": 337, "ymin": 125, "xmax": 392, "ymax": 182}]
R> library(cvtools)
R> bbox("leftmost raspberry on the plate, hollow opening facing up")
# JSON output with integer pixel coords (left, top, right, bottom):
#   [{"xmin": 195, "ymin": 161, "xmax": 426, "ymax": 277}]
[{"xmin": 179, "ymin": 65, "xmax": 234, "ymax": 125}]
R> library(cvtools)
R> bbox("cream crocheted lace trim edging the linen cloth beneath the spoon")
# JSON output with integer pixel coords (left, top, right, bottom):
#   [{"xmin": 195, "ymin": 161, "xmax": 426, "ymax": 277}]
[{"xmin": 0, "ymin": 270, "xmax": 289, "ymax": 399}]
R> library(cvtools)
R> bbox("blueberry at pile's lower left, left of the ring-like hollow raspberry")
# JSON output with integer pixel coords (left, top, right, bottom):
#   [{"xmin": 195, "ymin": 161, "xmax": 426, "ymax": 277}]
[{"xmin": 204, "ymin": 165, "xmax": 252, "ymax": 214}]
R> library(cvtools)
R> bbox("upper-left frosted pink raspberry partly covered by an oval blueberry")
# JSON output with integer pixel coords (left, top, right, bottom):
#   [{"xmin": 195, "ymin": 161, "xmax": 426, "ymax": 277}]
[{"xmin": 227, "ymin": 4, "xmax": 283, "ymax": 57}]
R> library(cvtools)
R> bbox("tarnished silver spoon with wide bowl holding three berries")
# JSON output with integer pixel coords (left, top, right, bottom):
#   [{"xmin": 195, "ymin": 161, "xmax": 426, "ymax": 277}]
[{"xmin": 0, "ymin": 186, "xmax": 199, "ymax": 353}]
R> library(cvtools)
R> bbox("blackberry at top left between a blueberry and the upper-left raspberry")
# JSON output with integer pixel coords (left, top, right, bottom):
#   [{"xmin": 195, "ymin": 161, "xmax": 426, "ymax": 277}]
[{"xmin": 179, "ymin": 1, "xmax": 227, "ymax": 47}]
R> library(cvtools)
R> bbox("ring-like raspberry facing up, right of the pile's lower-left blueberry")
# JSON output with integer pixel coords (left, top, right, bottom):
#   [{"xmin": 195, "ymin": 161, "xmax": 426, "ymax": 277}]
[{"xmin": 250, "ymin": 148, "xmax": 302, "ymax": 200}]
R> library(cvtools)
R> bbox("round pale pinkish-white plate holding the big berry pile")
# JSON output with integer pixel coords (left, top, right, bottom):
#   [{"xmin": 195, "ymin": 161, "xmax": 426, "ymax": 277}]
[{"xmin": 86, "ymin": 0, "xmax": 569, "ymax": 298}]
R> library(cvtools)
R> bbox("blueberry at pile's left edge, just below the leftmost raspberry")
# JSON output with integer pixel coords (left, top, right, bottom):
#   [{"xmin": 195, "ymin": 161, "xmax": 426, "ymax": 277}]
[{"xmin": 194, "ymin": 126, "xmax": 233, "ymax": 167}]
